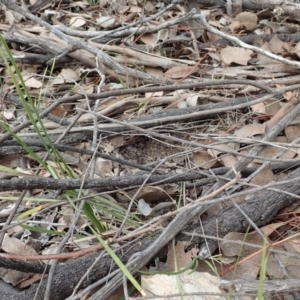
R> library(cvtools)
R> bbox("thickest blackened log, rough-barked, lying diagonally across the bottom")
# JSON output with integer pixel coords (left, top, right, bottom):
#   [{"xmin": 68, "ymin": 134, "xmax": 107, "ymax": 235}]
[{"xmin": 0, "ymin": 168, "xmax": 300, "ymax": 300}]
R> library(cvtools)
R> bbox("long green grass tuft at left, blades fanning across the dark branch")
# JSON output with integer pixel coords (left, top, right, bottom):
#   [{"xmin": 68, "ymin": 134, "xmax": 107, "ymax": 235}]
[{"xmin": 0, "ymin": 35, "xmax": 140, "ymax": 235}]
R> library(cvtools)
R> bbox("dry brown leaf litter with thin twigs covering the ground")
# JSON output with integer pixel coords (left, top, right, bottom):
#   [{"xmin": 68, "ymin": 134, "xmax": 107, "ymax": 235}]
[{"xmin": 0, "ymin": 0, "xmax": 300, "ymax": 299}]
